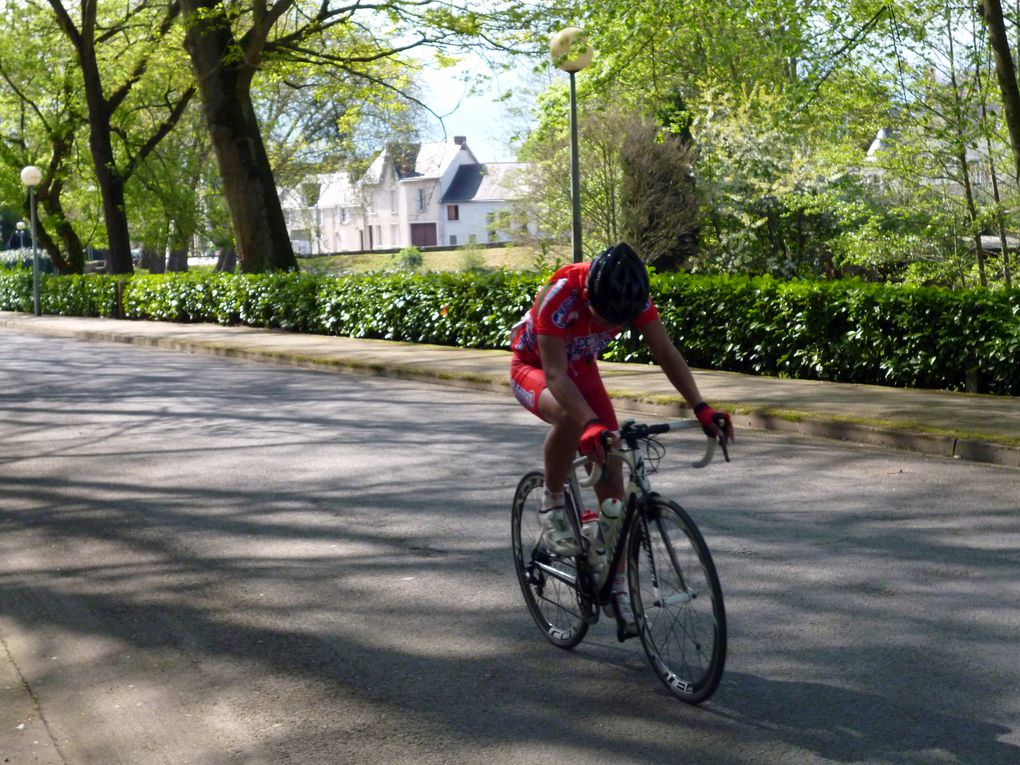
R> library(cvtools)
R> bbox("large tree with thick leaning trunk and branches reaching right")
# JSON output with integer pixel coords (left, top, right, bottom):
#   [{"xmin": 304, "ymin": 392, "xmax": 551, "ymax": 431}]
[{"xmin": 182, "ymin": 0, "xmax": 529, "ymax": 271}]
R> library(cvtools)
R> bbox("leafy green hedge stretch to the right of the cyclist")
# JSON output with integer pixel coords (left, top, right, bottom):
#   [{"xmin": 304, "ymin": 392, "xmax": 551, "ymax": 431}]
[{"xmin": 608, "ymin": 274, "xmax": 1020, "ymax": 395}]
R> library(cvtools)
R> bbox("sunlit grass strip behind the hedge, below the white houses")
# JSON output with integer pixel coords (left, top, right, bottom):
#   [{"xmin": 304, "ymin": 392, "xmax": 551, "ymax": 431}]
[{"xmin": 298, "ymin": 247, "xmax": 570, "ymax": 273}]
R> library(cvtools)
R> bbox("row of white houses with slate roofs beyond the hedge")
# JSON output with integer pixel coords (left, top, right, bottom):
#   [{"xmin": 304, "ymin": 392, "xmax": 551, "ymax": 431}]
[{"xmin": 281, "ymin": 136, "xmax": 525, "ymax": 254}]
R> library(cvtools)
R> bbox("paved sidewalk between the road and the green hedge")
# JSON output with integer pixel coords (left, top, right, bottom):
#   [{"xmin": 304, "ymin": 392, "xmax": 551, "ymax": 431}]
[{"xmin": 0, "ymin": 311, "xmax": 1020, "ymax": 467}]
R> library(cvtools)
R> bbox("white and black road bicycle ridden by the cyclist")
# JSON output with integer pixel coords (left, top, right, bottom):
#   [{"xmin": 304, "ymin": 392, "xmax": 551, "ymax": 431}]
[{"xmin": 511, "ymin": 420, "xmax": 729, "ymax": 704}]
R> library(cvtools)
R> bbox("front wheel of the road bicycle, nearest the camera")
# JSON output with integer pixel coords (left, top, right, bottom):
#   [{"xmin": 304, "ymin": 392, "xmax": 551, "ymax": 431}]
[{"xmin": 627, "ymin": 496, "xmax": 726, "ymax": 704}]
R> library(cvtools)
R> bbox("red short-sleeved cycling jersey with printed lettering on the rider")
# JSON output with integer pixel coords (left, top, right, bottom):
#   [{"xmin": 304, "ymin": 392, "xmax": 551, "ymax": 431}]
[{"xmin": 510, "ymin": 262, "xmax": 659, "ymax": 376}]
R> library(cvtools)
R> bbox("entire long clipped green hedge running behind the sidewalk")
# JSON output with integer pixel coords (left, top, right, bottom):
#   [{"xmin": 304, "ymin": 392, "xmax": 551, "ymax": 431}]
[{"xmin": 0, "ymin": 270, "xmax": 1020, "ymax": 396}]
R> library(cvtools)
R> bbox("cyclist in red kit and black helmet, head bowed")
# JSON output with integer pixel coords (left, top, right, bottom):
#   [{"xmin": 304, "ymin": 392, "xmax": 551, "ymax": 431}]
[{"xmin": 510, "ymin": 242, "xmax": 733, "ymax": 640}]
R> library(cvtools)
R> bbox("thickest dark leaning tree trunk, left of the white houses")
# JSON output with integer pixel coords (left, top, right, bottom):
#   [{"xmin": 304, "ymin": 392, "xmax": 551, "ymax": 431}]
[{"xmin": 182, "ymin": 7, "xmax": 298, "ymax": 273}]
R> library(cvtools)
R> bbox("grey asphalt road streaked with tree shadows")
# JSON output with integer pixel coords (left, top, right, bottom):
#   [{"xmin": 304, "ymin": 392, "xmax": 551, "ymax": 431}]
[{"xmin": 0, "ymin": 330, "xmax": 1020, "ymax": 765}]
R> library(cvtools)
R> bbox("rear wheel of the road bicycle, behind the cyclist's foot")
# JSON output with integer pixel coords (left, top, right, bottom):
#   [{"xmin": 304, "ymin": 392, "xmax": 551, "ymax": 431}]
[{"xmin": 510, "ymin": 470, "xmax": 588, "ymax": 648}]
